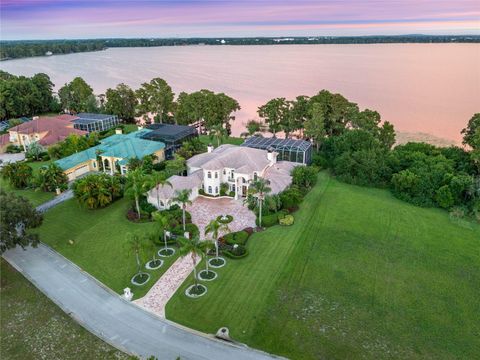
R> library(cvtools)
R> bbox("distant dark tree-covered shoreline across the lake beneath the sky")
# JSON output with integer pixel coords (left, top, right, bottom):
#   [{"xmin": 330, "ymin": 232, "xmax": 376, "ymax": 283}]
[{"xmin": 0, "ymin": 35, "xmax": 480, "ymax": 61}]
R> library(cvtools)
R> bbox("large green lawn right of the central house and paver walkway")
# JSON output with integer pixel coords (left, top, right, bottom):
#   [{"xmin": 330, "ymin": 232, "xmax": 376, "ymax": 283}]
[{"xmin": 166, "ymin": 173, "xmax": 480, "ymax": 359}]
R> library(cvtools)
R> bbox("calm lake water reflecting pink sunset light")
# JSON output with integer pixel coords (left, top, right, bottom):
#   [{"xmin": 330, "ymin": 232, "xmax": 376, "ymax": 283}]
[{"xmin": 0, "ymin": 44, "xmax": 480, "ymax": 141}]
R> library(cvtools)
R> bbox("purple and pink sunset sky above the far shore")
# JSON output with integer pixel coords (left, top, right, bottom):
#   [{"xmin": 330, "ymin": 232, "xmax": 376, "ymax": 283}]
[{"xmin": 0, "ymin": 0, "xmax": 480, "ymax": 40}]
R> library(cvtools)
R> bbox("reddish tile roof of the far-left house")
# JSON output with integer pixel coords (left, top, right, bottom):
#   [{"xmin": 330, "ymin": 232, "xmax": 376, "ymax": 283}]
[{"xmin": 9, "ymin": 114, "xmax": 88, "ymax": 146}]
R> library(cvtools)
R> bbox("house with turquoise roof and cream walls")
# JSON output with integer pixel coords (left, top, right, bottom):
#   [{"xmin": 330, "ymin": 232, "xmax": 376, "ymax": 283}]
[{"xmin": 55, "ymin": 129, "xmax": 165, "ymax": 181}]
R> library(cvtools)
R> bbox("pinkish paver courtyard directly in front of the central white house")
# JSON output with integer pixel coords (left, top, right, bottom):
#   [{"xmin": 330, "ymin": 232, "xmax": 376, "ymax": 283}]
[{"xmin": 187, "ymin": 196, "xmax": 255, "ymax": 239}]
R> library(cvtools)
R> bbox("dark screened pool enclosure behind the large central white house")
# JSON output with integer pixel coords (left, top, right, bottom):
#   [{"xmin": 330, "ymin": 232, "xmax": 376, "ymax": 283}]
[{"xmin": 242, "ymin": 136, "xmax": 312, "ymax": 165}]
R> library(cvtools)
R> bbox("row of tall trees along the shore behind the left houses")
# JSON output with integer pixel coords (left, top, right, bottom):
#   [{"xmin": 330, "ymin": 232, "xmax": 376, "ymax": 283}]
[{"xmin": 0, "ymin": 71, "xmax": 240, "ymax": 134}]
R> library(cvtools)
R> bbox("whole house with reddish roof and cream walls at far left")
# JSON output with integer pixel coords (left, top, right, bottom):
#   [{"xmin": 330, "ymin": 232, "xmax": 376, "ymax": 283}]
[{"xmin": 8, "ymin": 115, "xmax": 87, "ymax": 151}]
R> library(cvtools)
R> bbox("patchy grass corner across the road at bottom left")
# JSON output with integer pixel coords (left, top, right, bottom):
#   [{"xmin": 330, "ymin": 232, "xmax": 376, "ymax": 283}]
[{"xmin": 0, "ymin": 259, "xmax": 128, "ymax": 360}]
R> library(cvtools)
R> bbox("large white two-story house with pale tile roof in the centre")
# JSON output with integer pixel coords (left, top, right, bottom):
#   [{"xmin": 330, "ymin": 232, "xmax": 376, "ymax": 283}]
[{"xmin": 148, "ymin": 145, "xmax": 298, "ymax": 209}]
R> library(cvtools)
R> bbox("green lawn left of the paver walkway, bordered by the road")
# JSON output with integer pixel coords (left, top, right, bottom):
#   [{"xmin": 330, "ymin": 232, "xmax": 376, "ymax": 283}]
[{"xmin": 34, "ymin": 199, "xmax": 176, "ymax": 298}]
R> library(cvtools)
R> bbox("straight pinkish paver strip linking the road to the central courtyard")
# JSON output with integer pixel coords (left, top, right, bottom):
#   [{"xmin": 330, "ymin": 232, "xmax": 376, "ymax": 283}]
[{"xmin": 134, "ymin": 256, "xmax": 192, "ymax": 318}]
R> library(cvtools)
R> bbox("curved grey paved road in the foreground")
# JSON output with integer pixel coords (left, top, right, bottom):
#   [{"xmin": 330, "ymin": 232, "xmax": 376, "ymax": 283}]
[{"xmin": 3, "ymin": 244, "xmax": 282, "ymax": 360}]
